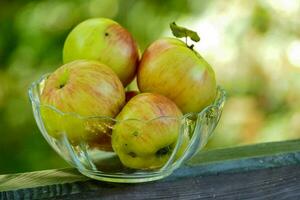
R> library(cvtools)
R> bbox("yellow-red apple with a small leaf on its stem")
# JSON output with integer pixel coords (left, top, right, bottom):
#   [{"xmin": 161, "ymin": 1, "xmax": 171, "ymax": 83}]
[{"xmin": 137, "ymin": 38, "xmax": 217, "ymax": 113}]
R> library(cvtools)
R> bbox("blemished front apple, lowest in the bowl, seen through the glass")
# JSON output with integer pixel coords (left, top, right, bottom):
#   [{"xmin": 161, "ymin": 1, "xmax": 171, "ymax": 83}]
[{"xmin": 112, "ymin": 93, "xmax": 189, "ymax": 169}]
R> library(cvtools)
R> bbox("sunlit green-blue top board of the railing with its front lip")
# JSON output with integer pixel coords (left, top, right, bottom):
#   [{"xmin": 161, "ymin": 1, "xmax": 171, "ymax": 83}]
[{"xmin": 0, "ymin": 140, "xmax": 300, "ymax": 199}]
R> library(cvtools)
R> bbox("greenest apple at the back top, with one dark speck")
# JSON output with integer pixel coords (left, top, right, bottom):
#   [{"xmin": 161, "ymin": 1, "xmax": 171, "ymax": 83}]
[{"xmin": 63, "ymin": 18, "xmax": 139, "ymax": 86}]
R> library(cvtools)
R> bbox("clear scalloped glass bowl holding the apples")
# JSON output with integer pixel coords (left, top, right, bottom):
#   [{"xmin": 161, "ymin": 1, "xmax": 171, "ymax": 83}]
[{"xmin": 29, "ymin": 75, "xmax": 226, "ymax": 183}]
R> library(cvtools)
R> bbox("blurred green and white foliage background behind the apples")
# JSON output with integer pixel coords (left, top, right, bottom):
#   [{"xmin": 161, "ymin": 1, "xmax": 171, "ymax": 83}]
[{"xmin": 0, "ymin": 0, "xmax": 300, "ymax": 174}]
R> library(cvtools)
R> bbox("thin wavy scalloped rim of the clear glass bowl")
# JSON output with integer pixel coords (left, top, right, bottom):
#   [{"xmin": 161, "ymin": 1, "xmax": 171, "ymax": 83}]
[{"xmin": 28, "ymin": 73, "xmax": 227, "ymax": 123}]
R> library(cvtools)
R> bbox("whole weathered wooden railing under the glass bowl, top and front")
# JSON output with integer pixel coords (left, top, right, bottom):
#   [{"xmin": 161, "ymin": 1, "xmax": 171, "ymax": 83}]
[{"xmin": 0, "ymin": 140, "xmax": 300, "ymax": 199}]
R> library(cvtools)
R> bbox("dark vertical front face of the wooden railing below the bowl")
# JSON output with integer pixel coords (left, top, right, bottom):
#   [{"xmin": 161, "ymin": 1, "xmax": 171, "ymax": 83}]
[{"xmin": 0, "ymin": 165, "xmax": 300, "ymax": 200}]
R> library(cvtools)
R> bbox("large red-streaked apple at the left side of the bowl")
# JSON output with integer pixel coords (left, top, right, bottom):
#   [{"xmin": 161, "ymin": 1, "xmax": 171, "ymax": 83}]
[{"xmin": 40, "ymin": 60, "xmax": 125, "ymax": 150}]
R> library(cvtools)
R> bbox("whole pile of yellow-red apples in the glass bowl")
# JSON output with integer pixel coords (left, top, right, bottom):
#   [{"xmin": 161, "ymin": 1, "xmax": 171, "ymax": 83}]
[{"xmin": 41, "ymin": 18, "xmax": 216, "ymax": 169}]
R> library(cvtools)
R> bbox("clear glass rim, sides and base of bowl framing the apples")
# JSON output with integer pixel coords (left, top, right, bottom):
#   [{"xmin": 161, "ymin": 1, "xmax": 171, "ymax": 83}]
[{"xmin": 28, "ymin": 74, "xmax": 226, "ymax": 183}]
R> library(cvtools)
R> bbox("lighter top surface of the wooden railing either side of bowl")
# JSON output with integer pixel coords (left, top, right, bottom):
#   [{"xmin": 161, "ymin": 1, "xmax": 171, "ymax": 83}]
[{"xmin": 0, "ymin": 140, "xmax": 300, "ymax": 193}]
